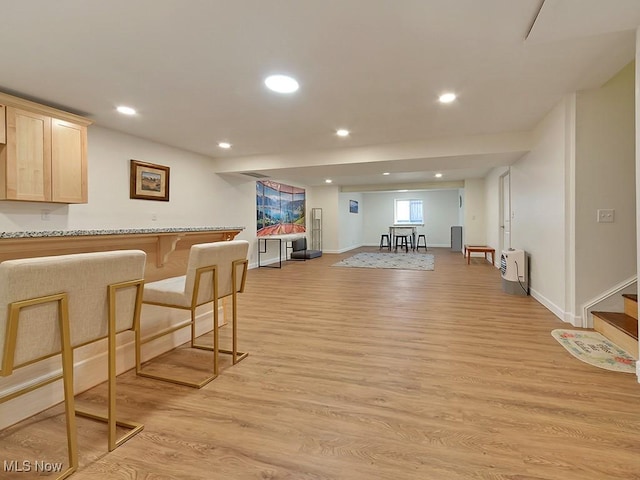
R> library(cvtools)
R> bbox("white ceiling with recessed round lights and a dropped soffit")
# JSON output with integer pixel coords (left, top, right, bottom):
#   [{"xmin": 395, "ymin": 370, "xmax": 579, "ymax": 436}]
[{"xmin": 0, "ymin": 0, "xmax": 640, "ymax": 186}]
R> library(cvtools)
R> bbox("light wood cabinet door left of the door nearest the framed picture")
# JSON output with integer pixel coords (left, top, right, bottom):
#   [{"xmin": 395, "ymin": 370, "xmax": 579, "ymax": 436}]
[{"xmin": 6, "ymin": 107, "xmax": 51, "ymax": 202}]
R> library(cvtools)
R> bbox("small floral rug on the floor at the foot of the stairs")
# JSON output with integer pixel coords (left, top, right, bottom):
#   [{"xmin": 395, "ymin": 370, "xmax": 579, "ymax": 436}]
[{"xmin": 551, "ymin": 330, "xmax": 636, "ymax": 373}]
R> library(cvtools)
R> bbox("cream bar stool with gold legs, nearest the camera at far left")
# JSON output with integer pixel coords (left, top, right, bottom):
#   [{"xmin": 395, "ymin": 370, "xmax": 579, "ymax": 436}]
[{"xmin": 0, "ymin": 251, "xmax": 145, "ymax": 479}]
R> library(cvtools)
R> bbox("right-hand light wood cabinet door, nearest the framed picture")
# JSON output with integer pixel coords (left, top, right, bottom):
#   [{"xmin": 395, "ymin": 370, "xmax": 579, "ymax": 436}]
[{"xmin": 51, "ymin": 118, "xmax": 87, "ymax": 203}]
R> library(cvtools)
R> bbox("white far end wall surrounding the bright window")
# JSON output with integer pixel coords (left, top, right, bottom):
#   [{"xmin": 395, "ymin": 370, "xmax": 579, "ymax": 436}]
[{"xmin": 363, "ymin": 189, "xmax": 459, "ymax": 247}]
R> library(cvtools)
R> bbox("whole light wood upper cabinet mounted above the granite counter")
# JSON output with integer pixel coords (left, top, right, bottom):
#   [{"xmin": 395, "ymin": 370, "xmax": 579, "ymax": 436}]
[{"xmin": 0, "ymin": 94, "xmax": 90, "ymax": 203}]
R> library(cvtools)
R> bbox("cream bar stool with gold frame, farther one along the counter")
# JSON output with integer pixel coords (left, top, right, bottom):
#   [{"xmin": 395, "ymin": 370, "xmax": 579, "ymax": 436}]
[{"xmin": 136, "ymin": 240, "xmax": 249, "ymax": 388}]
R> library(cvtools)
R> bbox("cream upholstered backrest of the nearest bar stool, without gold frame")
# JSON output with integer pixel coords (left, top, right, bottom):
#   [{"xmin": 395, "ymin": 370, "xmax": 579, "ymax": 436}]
[{"xmin": 0, "ymin": 250, "xmax": 146, "ymax": 367}]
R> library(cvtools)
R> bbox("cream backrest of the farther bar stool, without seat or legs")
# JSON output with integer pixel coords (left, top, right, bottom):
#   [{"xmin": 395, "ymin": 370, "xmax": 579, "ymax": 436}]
[{"xmin": 185, "ymin": 240, "xmax": 249, "ymax": 305}]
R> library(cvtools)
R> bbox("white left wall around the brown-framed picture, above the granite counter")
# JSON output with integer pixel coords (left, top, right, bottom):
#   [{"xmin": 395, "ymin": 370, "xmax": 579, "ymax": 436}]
[{"xmin": 0, "ymin": 126, "xmax": 255, "ymax": 246}]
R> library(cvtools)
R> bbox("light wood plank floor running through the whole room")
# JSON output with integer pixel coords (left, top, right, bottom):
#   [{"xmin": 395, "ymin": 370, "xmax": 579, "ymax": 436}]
[{"xmin": 0, "ymin": 248, "xmax": 640, "ymax": 480}]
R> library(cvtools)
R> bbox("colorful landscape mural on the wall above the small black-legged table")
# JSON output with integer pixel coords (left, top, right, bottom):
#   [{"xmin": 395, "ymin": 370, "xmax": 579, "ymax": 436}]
[{"xmin": 256, "ymin": 180, "xmax": 306, "ymax": 237}]
